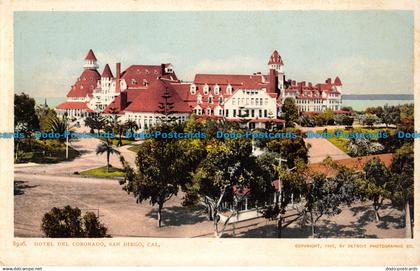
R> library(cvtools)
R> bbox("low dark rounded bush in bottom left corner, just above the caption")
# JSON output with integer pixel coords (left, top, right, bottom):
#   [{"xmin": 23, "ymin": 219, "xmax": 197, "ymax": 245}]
[{"xmin": 41, "ymin": 205, "xmax": 109, "ymax": 238}]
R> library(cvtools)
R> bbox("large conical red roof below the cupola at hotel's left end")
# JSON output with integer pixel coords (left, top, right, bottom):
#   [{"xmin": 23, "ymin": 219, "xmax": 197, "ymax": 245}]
[{"xmin": 67, "ymin": 69, "xmax": 101, "ymax": 97}]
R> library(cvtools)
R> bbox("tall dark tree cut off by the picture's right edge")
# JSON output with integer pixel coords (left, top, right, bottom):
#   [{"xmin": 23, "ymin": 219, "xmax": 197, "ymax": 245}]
[{"xmin": 389, "ymin": 143, "xmax": 414, "ymax": 231}]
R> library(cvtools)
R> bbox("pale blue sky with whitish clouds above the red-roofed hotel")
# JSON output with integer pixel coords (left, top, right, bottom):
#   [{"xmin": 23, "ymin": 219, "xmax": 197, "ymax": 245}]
[{"xmin": 14, "ymin": 11, "xmax": 414, "ymax": 97}]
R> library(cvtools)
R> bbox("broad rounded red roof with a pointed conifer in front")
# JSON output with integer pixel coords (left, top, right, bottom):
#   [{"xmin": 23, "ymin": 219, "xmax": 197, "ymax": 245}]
[{"xmin": 125, "ymin": 80, "xmax": 191, "ymax": 113}]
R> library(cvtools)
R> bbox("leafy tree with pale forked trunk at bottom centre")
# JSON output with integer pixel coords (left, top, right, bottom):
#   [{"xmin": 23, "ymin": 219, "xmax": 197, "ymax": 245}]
[{"xmin": 188, "ymin": 138, "xmax": 272, "ymax": 237}]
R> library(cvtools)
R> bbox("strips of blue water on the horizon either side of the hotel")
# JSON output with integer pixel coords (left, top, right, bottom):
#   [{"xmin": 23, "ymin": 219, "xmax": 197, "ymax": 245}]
[{"xmin": 35, "ymin": 94, "xmax": 414, "ymax": 111}]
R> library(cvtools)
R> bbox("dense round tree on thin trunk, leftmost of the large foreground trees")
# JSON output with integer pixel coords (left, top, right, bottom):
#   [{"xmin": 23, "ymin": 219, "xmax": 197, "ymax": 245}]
[{"xmin": 120, "ymin": 123, "xmax": 190, "ymax": 227}]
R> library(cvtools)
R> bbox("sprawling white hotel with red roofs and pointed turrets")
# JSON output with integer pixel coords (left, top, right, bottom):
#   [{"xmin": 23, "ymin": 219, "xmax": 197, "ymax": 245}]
[{"xmin": 56, "ymin": 50, "xmax": 342, "ymax": 130}]
